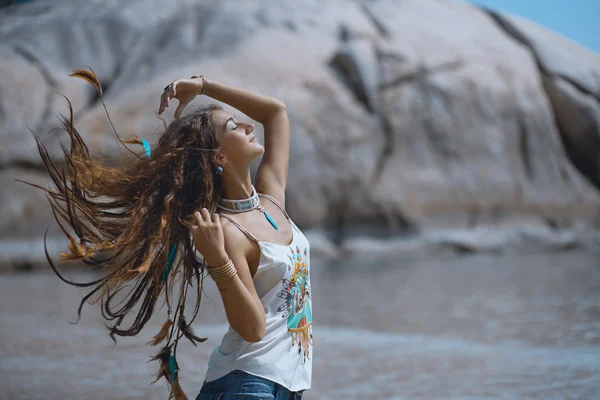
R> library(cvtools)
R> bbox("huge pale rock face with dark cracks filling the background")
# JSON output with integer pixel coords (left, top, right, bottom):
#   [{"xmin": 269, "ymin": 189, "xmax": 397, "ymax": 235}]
[{"xmin": 0, "ymin": 0, "xmax": 600, "ymax": 266}]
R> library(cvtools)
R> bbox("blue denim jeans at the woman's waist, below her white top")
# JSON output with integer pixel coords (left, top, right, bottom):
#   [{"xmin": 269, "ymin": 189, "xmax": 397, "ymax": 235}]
[{"xmin": 196, "ymin": 370, "xmax": 303, "ymax": 400}]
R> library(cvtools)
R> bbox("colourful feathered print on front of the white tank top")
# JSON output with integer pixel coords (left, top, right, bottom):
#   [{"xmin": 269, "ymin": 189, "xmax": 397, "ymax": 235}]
[{"xmin": 277, "ymin": 246, "xmax": 312, "ymax": 361}]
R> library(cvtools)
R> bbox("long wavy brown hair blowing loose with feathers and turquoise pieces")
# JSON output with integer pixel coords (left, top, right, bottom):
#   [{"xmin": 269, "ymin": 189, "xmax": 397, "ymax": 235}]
[{"xmin": 24, "ymin": 70, "xmax": 223, "ymax": 399}]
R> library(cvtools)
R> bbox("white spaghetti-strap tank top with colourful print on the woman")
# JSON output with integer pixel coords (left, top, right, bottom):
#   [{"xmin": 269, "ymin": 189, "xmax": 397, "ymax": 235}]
[{"xmin": 206, "ymin": 194, "xmax": 313, "ymax": 392}]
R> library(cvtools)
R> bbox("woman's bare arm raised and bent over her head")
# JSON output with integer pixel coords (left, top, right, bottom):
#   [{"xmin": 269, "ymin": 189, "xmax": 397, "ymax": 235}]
[{"xmin": 159, "ymin": 78, "xmax": 290, "ymax": 204}]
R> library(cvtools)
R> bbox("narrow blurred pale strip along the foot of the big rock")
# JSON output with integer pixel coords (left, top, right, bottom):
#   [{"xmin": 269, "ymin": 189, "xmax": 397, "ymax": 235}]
[{"xmin": 0, "ymin": 221, "xmax": 600, "ymax": 273}]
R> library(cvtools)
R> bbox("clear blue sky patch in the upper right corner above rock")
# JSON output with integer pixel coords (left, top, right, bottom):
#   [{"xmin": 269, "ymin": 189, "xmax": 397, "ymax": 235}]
[{"xmin": 467, "ymin": 0, "xmax": 600, "ymax": 54}]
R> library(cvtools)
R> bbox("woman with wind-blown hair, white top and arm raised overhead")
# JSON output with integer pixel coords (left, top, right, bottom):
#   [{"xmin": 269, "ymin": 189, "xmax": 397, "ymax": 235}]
[{"xmin": 34, "ymin": 71, "xmax": 312, "ymax": 400}]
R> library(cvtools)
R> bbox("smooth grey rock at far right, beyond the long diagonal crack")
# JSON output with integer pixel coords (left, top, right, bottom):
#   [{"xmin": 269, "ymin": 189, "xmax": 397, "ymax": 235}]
[{"xmin": 480, "ymin": 10, "xmax": 600, "ymax": 195}]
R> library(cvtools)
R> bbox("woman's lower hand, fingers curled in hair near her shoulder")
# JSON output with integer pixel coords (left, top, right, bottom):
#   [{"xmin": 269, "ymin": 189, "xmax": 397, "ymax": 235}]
[{"xmin": 186, "ymin": 208, "xmax": 229, "ymax": 267}]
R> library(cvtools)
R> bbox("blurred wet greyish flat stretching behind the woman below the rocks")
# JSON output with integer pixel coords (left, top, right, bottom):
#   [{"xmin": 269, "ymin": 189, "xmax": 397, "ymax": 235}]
[{"xmin": 0, "ymin": 252, "xmax": 600, "ymax": 400}]
